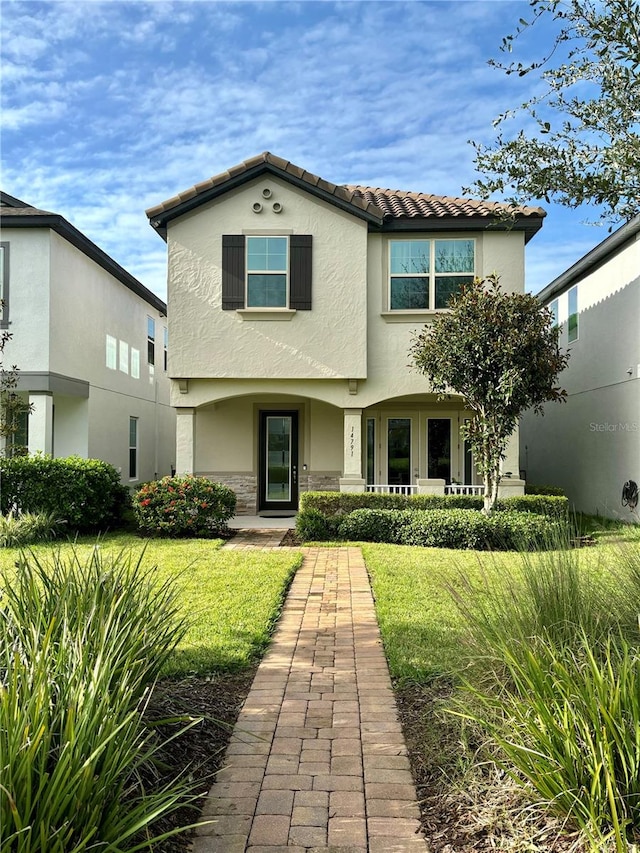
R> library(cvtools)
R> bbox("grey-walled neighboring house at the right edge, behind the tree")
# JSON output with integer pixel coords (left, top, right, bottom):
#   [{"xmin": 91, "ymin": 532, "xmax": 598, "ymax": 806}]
[{"xmin": 521, "ymin": 216, "xmax": 640, "ymax": 521}]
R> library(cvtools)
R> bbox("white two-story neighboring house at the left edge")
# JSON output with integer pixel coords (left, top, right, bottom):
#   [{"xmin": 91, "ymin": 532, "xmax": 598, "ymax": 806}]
[{"xmin": 0, "ymin": 193, "xmax": 175, "ymax": 484}]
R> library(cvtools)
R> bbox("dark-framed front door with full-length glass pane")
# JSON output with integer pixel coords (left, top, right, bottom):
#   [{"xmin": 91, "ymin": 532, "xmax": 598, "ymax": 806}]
[{"xmin": 258, "ymin": 411, "xmax": 298, "ymax": 512}]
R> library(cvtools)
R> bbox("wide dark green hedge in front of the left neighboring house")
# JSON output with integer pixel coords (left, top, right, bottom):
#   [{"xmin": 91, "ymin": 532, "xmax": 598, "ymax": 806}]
[{"xmin": 0, "ymin": 455, "xmax": 130, "ymax": 532}]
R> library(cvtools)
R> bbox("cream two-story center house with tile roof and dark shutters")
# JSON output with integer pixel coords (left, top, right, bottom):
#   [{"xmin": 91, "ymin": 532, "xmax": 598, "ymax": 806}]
[{"xmin": 147, "ymin": 152, "xmax": 544, "ymax": 513}]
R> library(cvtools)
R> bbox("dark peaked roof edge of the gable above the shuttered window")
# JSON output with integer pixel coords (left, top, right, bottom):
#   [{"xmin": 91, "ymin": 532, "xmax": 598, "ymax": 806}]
[{"xmin": 147, "ymin": 162, "xmax": 383, "ymax": 240}]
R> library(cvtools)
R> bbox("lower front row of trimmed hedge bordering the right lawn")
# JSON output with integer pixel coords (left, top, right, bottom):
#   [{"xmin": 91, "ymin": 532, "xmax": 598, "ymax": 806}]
[{"xmin": 338, "ymin": 509, "xmax": 564, "ymax": 551}]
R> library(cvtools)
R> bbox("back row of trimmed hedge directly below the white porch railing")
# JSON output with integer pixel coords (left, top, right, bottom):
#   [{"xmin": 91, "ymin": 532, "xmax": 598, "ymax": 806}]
[{"xmin": 300, "ymin": 492, "xmax": 569, "ymax": 521}]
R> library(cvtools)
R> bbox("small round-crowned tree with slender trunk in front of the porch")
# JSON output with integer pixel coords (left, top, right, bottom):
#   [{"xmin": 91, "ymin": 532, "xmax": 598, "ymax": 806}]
[{"xmin": 410, "ymin": 274, "xmax": 568, "ymax": 514}]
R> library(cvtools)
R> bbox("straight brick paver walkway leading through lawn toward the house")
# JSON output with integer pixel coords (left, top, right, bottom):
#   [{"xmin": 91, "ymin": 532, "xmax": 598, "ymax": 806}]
[{"xmin": 193, "ymin": 548, "xmax": 427, "ymax": 853}]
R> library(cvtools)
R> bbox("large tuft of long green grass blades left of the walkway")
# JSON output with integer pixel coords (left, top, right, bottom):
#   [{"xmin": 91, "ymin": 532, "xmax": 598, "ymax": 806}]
[{"xmin": 0, "ymin": 547, "xmax": 200, "ymax": 853}]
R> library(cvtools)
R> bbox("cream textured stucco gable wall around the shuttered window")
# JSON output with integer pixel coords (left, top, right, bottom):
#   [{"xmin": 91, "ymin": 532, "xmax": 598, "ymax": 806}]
[{"xmin": 168, "ymin": 177, "xmax": 367, "ymax": 379}]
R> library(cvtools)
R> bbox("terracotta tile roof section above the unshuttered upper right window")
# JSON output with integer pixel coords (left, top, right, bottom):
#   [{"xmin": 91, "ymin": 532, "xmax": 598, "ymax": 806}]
[{"xmin": 345, "ymin": 185, "xmax": 545, "ymax": 218}]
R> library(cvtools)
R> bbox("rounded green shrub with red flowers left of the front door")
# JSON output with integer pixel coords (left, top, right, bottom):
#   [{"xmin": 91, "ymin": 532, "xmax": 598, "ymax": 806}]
[{"xmin": 133, "ymin": 476, "xmax": 236, "ymax": 538}]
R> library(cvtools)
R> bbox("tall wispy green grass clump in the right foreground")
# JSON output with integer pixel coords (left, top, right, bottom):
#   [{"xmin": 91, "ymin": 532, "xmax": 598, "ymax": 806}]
[{"xmin": 454, "ymin": 528, "xmax": 640, "ymax": 853}]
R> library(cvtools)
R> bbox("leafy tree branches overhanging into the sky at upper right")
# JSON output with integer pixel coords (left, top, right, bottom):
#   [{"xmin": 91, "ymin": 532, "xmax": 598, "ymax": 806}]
[{"xmin": 467, "ymin": 0, "xmax": 640, "ymax": 222}]
